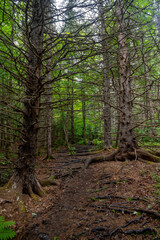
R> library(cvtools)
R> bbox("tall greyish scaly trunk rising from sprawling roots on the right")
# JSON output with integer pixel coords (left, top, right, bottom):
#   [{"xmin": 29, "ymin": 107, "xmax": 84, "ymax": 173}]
[{"xmin": 117, "ymin": 0, "xmax": 138, "ymax": 153}]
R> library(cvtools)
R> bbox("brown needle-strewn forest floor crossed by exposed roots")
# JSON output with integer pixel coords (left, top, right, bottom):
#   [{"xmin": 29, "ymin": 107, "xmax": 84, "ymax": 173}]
[{"xmin": 0, "ymin": 145, "xmax": 160, "ymax": 240}]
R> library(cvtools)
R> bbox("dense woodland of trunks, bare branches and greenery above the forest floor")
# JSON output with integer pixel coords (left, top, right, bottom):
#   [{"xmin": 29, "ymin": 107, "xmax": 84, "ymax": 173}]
[{"xmin": 0, "ymin": 0, "xmax": 160, "ymax": 193}]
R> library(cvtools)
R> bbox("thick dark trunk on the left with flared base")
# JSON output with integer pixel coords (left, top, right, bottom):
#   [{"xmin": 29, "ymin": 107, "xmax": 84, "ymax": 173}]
[{"xmin": 10, "ymin": 0, "xmax": 46, "ymax": 195}]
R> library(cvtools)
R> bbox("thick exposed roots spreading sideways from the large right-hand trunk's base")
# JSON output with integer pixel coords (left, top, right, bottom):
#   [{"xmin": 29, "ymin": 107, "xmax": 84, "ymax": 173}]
[{"xmin": 84, "ymin": 149, "xmax": 160, "ymax": 168}]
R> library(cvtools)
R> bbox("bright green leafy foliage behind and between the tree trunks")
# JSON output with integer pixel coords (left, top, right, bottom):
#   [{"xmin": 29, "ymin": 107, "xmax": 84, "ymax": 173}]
[{"xmin": 0, "ymin": 0, "xmax": 160, "ymax": 165}]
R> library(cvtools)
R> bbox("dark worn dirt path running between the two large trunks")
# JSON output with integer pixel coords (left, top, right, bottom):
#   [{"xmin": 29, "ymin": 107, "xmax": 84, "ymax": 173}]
[{"xmin": 22, "ymin": 146, "xmax": 97, "ymax": 240}]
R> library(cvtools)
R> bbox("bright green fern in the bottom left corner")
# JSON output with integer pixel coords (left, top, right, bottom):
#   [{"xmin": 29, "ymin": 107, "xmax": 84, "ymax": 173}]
[{"xmin": 0, "ymin": 216, "xmax": 16, "ymax": 240}]
